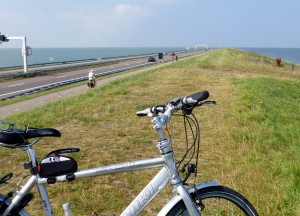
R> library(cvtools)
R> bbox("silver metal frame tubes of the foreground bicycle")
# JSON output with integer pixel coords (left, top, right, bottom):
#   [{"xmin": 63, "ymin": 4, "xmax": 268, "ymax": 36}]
[{"xmin": 3, "ymin": 152, "xmax": 200, "ymax": 216}]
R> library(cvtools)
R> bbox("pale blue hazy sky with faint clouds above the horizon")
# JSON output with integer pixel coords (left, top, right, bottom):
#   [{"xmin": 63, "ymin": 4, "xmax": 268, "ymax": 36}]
[{"xmin": 0, "ymin": 0, "xmax": 300, "ymax": 48}]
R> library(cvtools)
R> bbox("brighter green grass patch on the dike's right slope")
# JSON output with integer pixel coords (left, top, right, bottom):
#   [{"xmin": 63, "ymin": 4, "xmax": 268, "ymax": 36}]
[{"xmin": 233, "ymin": 78, "xmax": 300, "ymax": 215}]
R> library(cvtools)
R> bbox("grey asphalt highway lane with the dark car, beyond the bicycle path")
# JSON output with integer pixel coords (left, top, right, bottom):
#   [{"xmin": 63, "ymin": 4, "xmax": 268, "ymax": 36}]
[{"xmin": 0, "ymin": 53, "xmax": 204, "ymax": 99}]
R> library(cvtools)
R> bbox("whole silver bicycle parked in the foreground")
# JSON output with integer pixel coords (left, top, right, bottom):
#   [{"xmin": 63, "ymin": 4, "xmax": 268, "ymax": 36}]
[{"xmin": 0, "ymin": 91, "xmax": 258, "ymax": 216}]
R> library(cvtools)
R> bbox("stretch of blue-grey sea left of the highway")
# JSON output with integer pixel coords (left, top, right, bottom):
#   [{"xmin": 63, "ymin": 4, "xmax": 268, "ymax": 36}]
[{"xmin": 0, "ymin": 47, "xmax": 186, "ymax": 68}]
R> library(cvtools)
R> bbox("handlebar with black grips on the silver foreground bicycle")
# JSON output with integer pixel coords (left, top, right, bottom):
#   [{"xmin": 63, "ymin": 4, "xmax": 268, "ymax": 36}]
[{"xmin": 136, "ymin": 91, "xmax": 211, "ymax": 116}]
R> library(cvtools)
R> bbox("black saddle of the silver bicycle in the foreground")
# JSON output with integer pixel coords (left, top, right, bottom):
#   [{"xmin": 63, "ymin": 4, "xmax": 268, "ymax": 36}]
[{"xmin": 0, "ymin": 128, "xmax": 61, "ymax": 147}]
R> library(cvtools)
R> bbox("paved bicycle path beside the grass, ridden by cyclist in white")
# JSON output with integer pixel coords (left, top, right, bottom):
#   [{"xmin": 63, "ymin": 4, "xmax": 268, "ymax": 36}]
[{"xmin": 0, "ymin": 62, "xmax": 172, "ymax": 120}]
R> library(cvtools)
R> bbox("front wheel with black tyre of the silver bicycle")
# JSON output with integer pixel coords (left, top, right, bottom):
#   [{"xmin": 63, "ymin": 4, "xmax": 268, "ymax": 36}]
[{"xmin": 167, "ymin": 186, "xmax": 258, "ymax": 216}]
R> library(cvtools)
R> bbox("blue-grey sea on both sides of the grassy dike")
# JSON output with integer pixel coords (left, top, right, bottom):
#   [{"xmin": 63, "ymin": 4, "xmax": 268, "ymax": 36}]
[{"xmin": 0, "ymin": 47, "xmax": 300, "ymax": 68}]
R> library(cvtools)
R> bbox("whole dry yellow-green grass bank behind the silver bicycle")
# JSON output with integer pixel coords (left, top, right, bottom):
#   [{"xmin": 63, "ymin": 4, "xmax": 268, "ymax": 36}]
[{"xmin": 0, "ymin": 49, "xmax": 300, "ymax": 215}]
